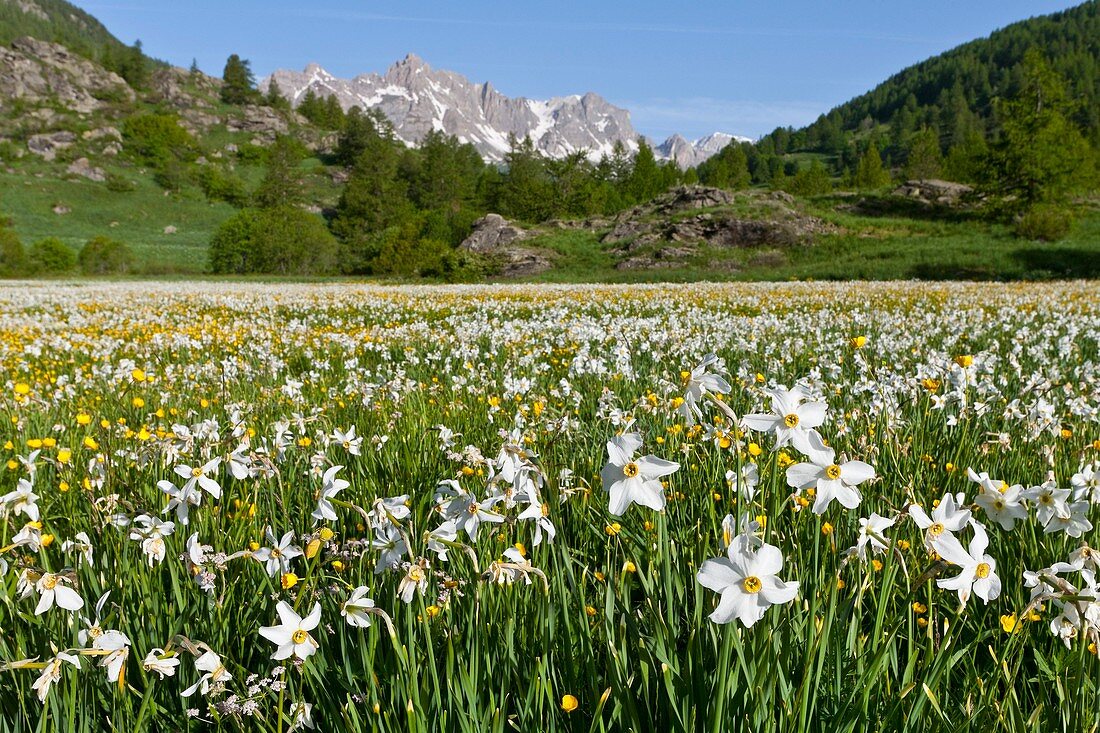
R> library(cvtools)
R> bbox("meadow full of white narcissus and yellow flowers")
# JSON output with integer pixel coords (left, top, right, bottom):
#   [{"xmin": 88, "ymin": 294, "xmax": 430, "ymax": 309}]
[{"xmin": 0, "ymin": 283, "xmax": 1100, "ymax": 733}]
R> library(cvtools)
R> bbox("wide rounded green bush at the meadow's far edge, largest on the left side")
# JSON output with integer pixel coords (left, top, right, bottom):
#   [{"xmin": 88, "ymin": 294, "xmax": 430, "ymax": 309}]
[{"xmin": 210, "ymin": 206, "xmax": 337, "ymax": 275}]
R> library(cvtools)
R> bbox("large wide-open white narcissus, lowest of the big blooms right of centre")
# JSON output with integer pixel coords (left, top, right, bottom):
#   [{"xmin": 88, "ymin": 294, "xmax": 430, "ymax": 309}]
[{"xmin": 696, "ymin": 534, "xmax": 799, "ymax": 626}]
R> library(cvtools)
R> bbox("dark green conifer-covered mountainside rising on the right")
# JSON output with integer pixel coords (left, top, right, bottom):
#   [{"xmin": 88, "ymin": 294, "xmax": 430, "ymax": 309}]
[{"xmin": 763, "ymin": 0, "xmax": 1100, "ymax": 154}]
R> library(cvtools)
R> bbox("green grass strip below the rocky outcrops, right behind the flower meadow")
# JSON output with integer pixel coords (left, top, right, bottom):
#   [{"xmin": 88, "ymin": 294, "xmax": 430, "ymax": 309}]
[{"xmin": 525, "ymin": 196, "xmax": 1100, "ymax": 283}]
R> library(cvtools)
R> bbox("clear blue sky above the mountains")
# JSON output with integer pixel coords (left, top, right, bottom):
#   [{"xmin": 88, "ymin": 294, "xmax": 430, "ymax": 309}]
[{"xmin": 77, "ymin": 0, "xmax": 1076, "ymax": 139}]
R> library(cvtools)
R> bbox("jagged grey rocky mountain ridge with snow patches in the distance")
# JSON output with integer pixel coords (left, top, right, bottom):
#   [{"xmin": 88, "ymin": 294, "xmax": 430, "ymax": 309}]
[{"xmin": 260, "ymin": 54, "xmax": 744, "ymax": 167}]
